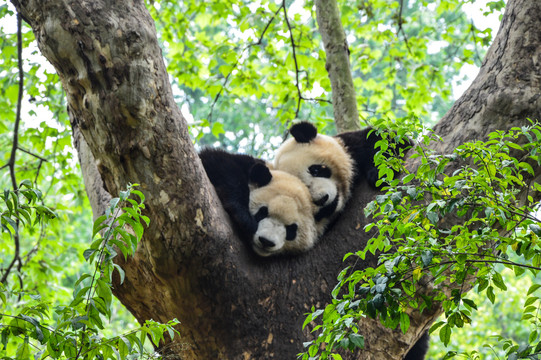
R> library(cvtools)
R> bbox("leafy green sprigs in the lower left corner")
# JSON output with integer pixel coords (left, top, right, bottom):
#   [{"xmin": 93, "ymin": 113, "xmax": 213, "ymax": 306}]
[{"xmin": 0, "ymin": 181, "xmax": 178, "ymax": 360}]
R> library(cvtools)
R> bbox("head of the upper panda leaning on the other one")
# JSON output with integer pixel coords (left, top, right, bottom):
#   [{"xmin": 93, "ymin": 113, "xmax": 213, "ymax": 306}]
[{"xmin": 274, "ymin": 122, "xmax": 355, "ymax": 226}]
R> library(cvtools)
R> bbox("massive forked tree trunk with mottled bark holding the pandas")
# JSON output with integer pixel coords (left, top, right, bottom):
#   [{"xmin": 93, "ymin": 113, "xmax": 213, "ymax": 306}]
[{"xmin": 12, "ymin": 0, "xmax": 541, "ymax": 360}]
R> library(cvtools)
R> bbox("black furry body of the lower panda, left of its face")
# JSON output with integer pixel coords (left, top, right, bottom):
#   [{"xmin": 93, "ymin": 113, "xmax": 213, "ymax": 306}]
[{"xmin": 199, "ymin": 149, "xmax": 264, "ymax": 241}]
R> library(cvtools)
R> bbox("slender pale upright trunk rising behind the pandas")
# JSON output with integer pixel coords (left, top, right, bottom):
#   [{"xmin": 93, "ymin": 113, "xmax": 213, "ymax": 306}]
[{"xmin": 315, "ymin": 0, "xmax": 360, "ymax": 132}]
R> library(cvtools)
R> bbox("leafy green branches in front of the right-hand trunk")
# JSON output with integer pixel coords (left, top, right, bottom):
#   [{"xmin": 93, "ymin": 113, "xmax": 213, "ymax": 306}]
[{"xmin": 303, "ymin": 124, "xmax": 541, "ymax": 359}]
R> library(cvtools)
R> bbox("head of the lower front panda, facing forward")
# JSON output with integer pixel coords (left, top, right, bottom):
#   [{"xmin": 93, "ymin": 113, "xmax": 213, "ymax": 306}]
[{"xmin": 249, "ymin": 164, "xmax": 317, "ymax": 256}]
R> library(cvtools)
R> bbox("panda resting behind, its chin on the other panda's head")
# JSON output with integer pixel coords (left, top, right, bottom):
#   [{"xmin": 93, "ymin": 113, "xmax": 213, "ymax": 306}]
[{"xmin": 274, "ymin": 122, "xmax": 410, "ymax": 233}]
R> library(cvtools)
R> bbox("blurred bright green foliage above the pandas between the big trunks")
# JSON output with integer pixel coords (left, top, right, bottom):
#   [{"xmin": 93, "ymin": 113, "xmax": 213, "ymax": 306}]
[{"xmin": 149, "ymin": 0, "xmax": 494, "ymax": 155}]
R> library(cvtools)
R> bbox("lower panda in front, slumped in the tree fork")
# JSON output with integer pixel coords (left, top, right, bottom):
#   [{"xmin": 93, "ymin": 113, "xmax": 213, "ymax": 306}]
[{"xmin": 199, "ymin": 149, "xmax": 318, "ymax": 256}]
